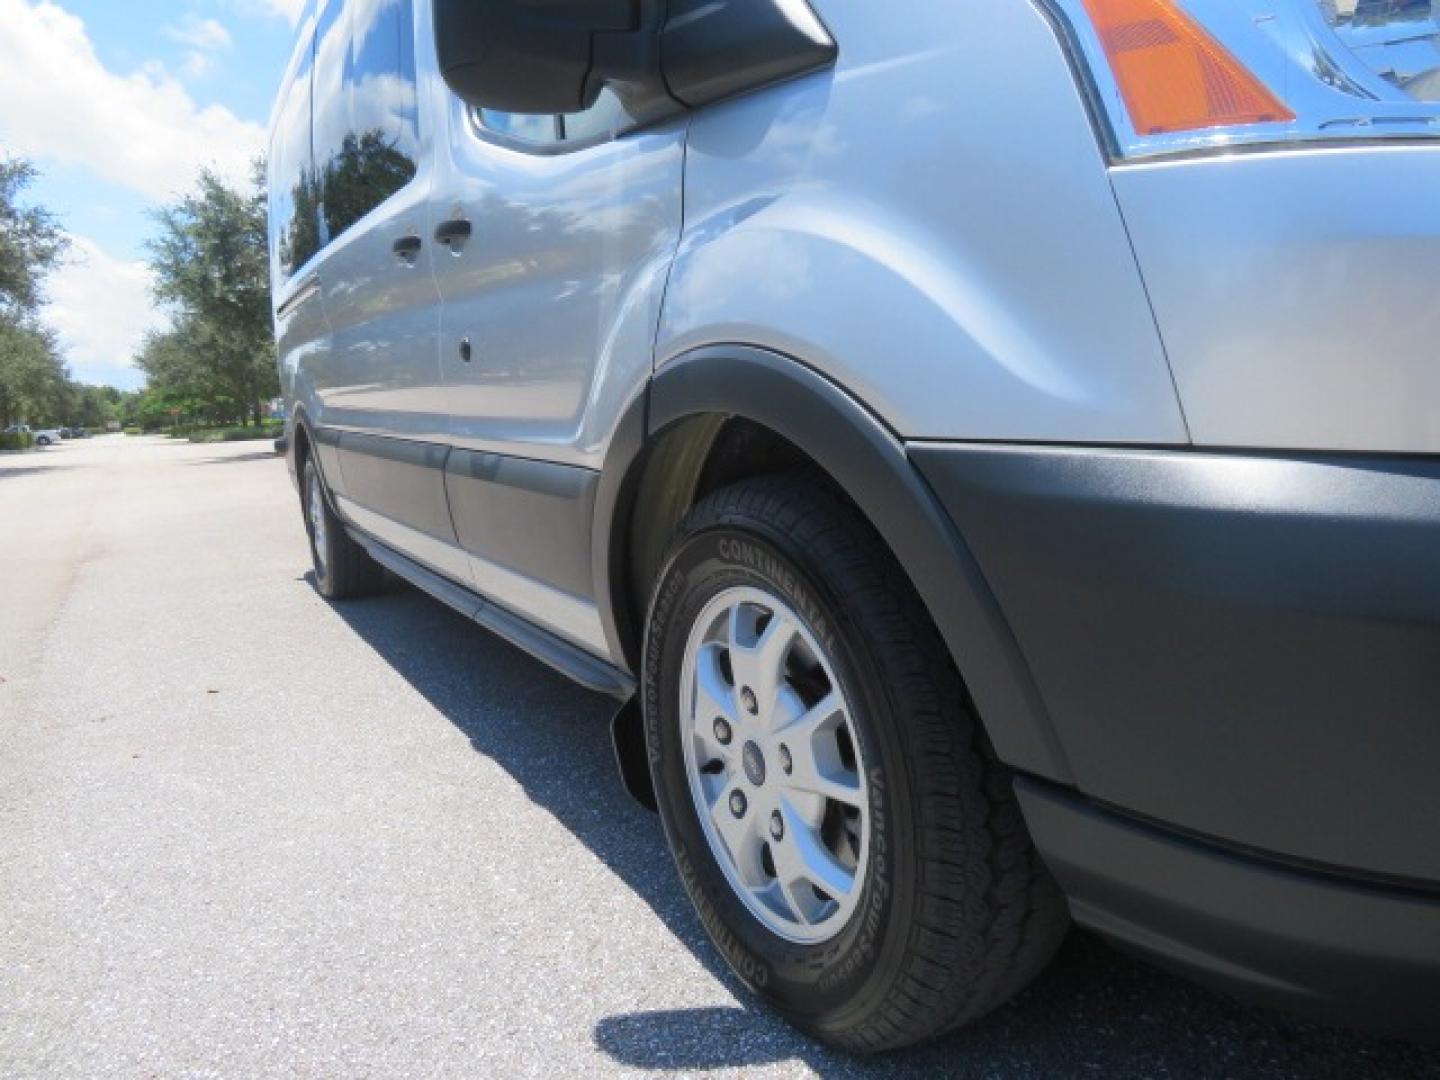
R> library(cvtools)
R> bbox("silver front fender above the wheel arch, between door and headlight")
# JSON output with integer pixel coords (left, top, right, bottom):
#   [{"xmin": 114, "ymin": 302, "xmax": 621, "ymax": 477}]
[{"xmin": 657, "ymin": 0, "xmax": 1188, "ymax": 444}]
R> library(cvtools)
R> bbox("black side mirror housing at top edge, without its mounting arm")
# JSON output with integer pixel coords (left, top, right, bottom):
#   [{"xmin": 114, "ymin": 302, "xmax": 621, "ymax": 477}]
[{"xmin": 435, "ymin": 0, "xmax": 662, "ymax": 114}]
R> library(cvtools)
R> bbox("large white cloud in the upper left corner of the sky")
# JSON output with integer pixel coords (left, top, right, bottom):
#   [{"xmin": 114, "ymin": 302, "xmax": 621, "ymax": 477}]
[{"xmin": 0, "ymin": 0, "xmax": 264, "ymax": 199}]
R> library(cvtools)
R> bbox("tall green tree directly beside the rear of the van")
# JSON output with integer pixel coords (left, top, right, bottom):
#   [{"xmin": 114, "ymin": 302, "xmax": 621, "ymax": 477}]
[{"xmin": 138, "ymin": 167, "xmax": 279, "ymax": 423}]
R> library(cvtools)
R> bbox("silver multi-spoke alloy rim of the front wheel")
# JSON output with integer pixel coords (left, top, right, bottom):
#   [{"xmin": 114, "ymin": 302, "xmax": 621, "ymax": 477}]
[{"xmin": 680, "ymin": 588, "xmax": 870, "ymax": 945}]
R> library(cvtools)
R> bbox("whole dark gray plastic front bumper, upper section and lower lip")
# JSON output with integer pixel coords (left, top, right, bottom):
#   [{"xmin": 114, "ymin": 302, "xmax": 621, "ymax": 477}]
[{"xmin": 910, "ymin": 445, "xmax": 1440, "ymax": 1028}]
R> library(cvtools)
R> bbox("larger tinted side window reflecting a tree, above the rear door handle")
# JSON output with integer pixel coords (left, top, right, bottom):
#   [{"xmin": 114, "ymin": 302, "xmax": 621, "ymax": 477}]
[{"xmin": 315, "ymin": 0, "xmax": 419, "ymax": 240}]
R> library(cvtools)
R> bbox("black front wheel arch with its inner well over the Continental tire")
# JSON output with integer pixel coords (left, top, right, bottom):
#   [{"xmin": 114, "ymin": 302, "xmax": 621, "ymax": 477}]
[{"xmin": 592, "ymin": 344, "xmax": 1071, "ymax": 782}]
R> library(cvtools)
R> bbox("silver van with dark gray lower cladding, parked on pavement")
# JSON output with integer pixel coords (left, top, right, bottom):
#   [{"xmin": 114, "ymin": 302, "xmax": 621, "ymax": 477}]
[{"xmin": 269, "ymin": 0, "xmax": 1440, "ymax": 1050}]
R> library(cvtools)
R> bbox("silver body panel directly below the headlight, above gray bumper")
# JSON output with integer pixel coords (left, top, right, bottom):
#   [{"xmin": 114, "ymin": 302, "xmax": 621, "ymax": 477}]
[{"xmin": 1113, "ymin": 141, "xmax": 1440, "ymax": 454}]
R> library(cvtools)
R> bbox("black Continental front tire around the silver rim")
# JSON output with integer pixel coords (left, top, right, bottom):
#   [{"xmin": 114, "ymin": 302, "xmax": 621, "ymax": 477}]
[{"xmin": 644, "ymin": 477, "xmax": 1068, "ymax": 1051}]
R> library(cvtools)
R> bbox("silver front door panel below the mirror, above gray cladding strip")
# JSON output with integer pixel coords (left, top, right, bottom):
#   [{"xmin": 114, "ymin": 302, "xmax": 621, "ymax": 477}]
[{"xmin": 432, "ymin": 99, "xmax": 687, "ymax": 468}]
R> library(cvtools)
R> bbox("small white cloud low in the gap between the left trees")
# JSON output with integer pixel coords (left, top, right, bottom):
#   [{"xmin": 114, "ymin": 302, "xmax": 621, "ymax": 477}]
[{"xmin": 45, "ymin": 236, "xmax": 166, "ymax": 382}]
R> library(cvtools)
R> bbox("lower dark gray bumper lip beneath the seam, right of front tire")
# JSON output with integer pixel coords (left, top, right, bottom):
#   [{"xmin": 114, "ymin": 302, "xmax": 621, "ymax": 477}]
[{"xmin": 1017, "ymin": 779, "xmax": 1440, "ymax": 1043}]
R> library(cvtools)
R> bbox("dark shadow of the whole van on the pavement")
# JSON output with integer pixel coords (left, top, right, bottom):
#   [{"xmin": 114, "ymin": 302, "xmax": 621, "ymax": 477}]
[{"xmin": 326, "ymin": 575, "xmax": 1440, "ymax": 1080}]
